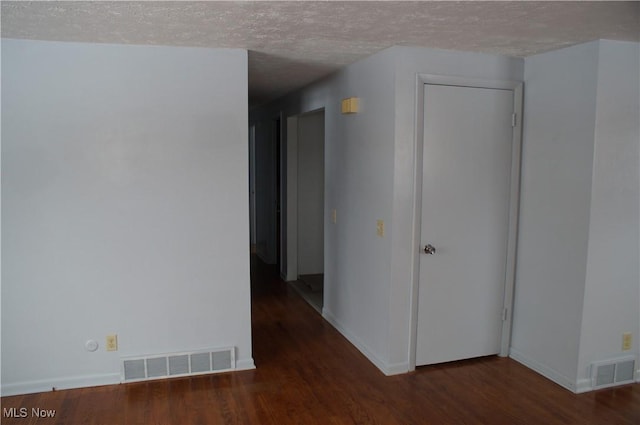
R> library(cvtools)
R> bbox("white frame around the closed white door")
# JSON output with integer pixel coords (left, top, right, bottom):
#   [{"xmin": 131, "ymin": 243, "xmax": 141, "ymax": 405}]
[{"xmin": 409, "ymin": 74, "xmax": 523, "ymax": 371}]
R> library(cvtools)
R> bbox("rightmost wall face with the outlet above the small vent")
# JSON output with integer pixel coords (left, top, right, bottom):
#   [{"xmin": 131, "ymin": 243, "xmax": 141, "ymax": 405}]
[{"xmin": 577, "ymin": 40, "xmax": 640, "ymax": 390}]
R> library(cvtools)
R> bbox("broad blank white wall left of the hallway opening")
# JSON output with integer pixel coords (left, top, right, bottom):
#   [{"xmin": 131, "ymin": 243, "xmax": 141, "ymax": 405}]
[{"xmin": 2, "ymin": 39, "xmax": 253, "ymax": 395}]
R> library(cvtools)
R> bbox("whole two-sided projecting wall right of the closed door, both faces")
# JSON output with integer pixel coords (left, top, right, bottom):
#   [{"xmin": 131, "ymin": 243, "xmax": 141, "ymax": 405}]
[{"xmin": 512, "ymin": 41, "xmax": 640, "ymax": 391}]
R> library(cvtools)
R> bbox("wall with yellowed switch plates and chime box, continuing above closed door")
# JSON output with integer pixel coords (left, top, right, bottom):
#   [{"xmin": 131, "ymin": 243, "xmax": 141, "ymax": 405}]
[{"xmin": 250, "ymin": 47, "xmax": 523, "ymax": 374}]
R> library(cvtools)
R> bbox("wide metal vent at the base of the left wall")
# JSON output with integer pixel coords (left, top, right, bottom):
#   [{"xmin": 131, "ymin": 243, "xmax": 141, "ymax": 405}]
[{"xmin": 120, "ymin": 347, "xmax": 236, "ymax": 382}]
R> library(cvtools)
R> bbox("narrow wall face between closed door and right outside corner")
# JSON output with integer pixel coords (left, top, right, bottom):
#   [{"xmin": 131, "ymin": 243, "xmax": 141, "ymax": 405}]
[{"xmin": 512, "ymin": 42, "xmax": 598, "ymax": 388}]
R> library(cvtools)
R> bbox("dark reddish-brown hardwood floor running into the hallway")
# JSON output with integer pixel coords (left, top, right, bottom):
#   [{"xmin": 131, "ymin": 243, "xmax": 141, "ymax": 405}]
[{"xmin": 2, "ymin": 260, "xmax": 640, "ymax": 425}]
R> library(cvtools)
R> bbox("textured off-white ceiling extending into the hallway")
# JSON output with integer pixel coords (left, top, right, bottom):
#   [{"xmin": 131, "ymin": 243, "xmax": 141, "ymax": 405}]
[{"xmin": 2, "ymin": 1, "xmax": 640, "ymax": 105}]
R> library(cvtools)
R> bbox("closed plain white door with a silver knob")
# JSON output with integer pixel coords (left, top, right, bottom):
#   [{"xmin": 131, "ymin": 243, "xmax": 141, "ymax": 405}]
[{"xmin": 416, "ymin": 84, "xmax": 514, "ymax": 366}]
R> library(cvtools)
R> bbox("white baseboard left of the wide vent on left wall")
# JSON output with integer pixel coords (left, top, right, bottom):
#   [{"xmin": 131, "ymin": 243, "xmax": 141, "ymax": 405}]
[{"xmin": 1, "ymin": 373, "xmax": 120, "ymax": 397}]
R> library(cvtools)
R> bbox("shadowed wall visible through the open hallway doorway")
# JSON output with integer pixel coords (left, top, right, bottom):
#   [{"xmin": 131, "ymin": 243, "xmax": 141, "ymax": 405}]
[{"xmin": 297, "ymin": 111, "xmax": 324, "ymax": 275}]
